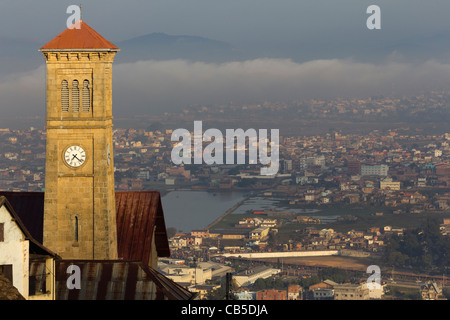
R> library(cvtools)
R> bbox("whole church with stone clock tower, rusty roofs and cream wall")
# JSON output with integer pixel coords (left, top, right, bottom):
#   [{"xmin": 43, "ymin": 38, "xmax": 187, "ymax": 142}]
[{"xmin": 0, "ymin": 20, "xmax": 195, "ymax": 300}]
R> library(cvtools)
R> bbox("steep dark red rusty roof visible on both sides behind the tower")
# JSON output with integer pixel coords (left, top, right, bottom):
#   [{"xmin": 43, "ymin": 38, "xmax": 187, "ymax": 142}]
[{"xmin": 0, "ymin": 191, "xmax": 170, "ymax": 263}]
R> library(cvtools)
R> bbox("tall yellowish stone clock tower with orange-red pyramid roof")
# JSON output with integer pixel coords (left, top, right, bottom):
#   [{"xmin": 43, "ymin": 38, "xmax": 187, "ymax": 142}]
[{"xmin": 40, "ymin": 20, "xmax": 119, "ymax": 260}]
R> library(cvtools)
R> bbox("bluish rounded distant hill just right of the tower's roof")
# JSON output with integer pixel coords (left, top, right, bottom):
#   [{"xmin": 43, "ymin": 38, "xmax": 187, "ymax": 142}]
[{"xmin": 115, "ymin": 33, "xmax": 243, "ymax": 62}]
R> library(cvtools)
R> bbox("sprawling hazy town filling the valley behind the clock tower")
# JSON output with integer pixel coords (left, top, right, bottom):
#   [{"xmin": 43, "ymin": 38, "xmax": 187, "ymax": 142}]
[{"xmin": 0, "ymin": 92, "xmax": 450, "ymax": 300}]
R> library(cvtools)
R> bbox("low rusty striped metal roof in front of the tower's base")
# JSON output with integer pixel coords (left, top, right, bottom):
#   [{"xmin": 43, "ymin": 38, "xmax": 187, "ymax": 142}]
[{"xmin": 52, "ymin": 260, "xmax": 195, "ymax": 300}]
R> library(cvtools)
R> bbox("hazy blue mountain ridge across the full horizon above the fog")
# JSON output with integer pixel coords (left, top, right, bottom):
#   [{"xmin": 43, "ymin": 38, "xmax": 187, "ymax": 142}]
[{"xmin": 0, "ymin": 27, "xmax": 450, "ymax": 74}]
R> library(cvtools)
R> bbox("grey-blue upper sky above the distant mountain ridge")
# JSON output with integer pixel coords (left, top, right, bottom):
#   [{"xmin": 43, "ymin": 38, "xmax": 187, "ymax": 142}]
[{"xmin": 0, "ymin": 0, "xmax": 450, "ymax": 55}]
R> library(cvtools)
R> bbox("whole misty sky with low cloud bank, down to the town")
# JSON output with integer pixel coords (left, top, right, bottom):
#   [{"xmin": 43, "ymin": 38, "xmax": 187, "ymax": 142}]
[{"xmin": 0, "ymin": 0, "xmax": 450, "ymax": 124}]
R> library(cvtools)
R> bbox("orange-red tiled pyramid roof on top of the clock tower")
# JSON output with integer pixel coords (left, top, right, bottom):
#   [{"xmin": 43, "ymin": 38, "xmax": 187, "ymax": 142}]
[{"xmin": 41, "ymin": 20, "xmax": 119, "ymax": 50}]
